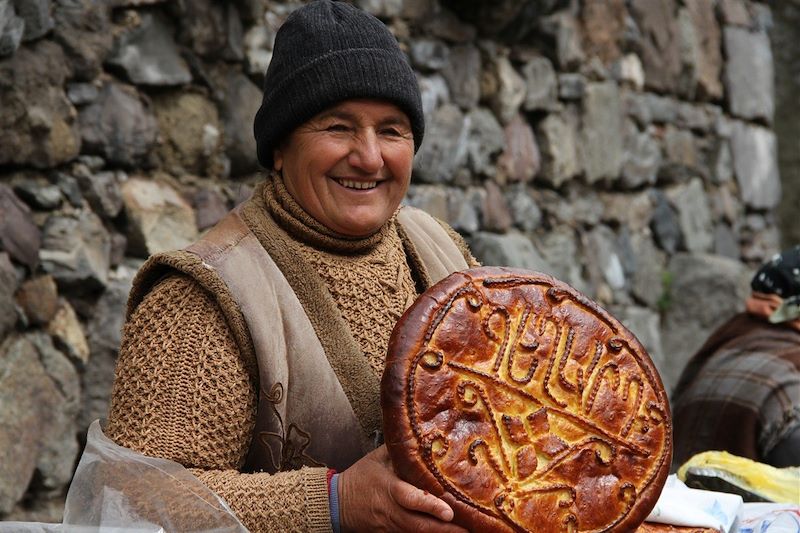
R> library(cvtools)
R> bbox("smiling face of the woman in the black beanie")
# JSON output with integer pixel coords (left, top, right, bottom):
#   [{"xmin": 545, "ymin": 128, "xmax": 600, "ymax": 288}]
[{"xmin": 275, "ymin": 100, "xmax": 414, "ymax": 237}]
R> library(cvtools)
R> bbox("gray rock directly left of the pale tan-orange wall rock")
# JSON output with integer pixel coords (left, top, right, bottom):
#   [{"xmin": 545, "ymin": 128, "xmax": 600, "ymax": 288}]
[{"xmin": 39, "ymin": 210, "xmax": 111, "ymax": 295}]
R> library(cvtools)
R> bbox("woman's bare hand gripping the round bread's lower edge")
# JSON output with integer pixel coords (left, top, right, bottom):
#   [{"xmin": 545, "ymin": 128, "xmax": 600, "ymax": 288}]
[{"xmin": 339, "ymin": 445, "xmax": 466, "ymax": 533}]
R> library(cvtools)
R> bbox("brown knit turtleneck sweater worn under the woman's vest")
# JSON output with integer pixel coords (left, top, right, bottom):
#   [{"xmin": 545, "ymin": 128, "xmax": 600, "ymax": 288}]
[{"xmin": 106, "ymin": 178, "xmax": 477, "ymax": 531}]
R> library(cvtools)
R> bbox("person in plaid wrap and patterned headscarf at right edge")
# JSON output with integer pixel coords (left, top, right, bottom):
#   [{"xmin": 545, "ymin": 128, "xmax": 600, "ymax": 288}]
[{"xmin": 673, "ymin": 245, "xmax": 800, "ymax": 467}]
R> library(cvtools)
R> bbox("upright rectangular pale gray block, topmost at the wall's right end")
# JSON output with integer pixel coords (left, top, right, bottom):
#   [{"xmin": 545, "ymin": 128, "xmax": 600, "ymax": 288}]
[{"xmin": 723, "ymin": 26, "xmax": 775, "ymax": 123}]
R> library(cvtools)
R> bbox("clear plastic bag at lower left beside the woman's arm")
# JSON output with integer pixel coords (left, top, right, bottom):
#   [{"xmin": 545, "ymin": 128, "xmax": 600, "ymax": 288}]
[{"xmin": 0, "ymin": 420, "xmax": 247, "ymax": 533}]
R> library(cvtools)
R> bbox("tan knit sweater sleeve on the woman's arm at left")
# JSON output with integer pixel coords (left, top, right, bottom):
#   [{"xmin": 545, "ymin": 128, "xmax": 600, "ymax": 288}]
[{"xmin": 106, "ymin": 275, "xmax": 330, "ymax": 532}]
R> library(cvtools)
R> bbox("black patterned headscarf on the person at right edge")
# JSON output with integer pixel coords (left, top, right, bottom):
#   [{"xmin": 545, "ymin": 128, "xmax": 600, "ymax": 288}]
[{"xmin": 750, "ymin": 245, "xmax": 800, "ymax": 323}]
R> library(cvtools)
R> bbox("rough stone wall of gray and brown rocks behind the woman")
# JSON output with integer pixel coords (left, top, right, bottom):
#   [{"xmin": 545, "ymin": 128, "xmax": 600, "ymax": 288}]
[{"xmin": 0, "ymin": 0, "xmax": 780, "ymax": 520}]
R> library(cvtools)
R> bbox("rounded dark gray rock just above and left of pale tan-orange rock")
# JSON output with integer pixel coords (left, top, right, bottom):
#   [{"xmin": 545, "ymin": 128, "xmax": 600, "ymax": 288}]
[{"xmin": 80, "ymin": 82, "xmax": 158, "ymax": 168}]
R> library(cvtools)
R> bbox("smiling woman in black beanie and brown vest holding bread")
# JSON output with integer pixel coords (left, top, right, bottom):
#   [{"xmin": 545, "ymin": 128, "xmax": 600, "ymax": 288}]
[{"xmin": 106, "ymin": 0, "xmax": 476, "ymax": 531}]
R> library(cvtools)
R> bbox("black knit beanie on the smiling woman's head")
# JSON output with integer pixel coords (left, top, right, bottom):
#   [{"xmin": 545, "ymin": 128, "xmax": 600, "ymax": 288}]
[{"xmin": 253, "ymin": 0, "xmax": 425, "ymax": 169}]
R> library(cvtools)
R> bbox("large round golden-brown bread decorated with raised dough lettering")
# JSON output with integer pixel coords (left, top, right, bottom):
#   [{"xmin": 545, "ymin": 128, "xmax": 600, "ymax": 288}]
[{"xmin": 381, "ymin": 267, "xmax": 672, "ymax": 533}]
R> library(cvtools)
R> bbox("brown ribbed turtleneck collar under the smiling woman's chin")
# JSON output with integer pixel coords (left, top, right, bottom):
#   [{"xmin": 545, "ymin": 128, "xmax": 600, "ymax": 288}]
[{"xmin": 264, "ymin": 172, "xmax": 396, "ymax": 254}]
